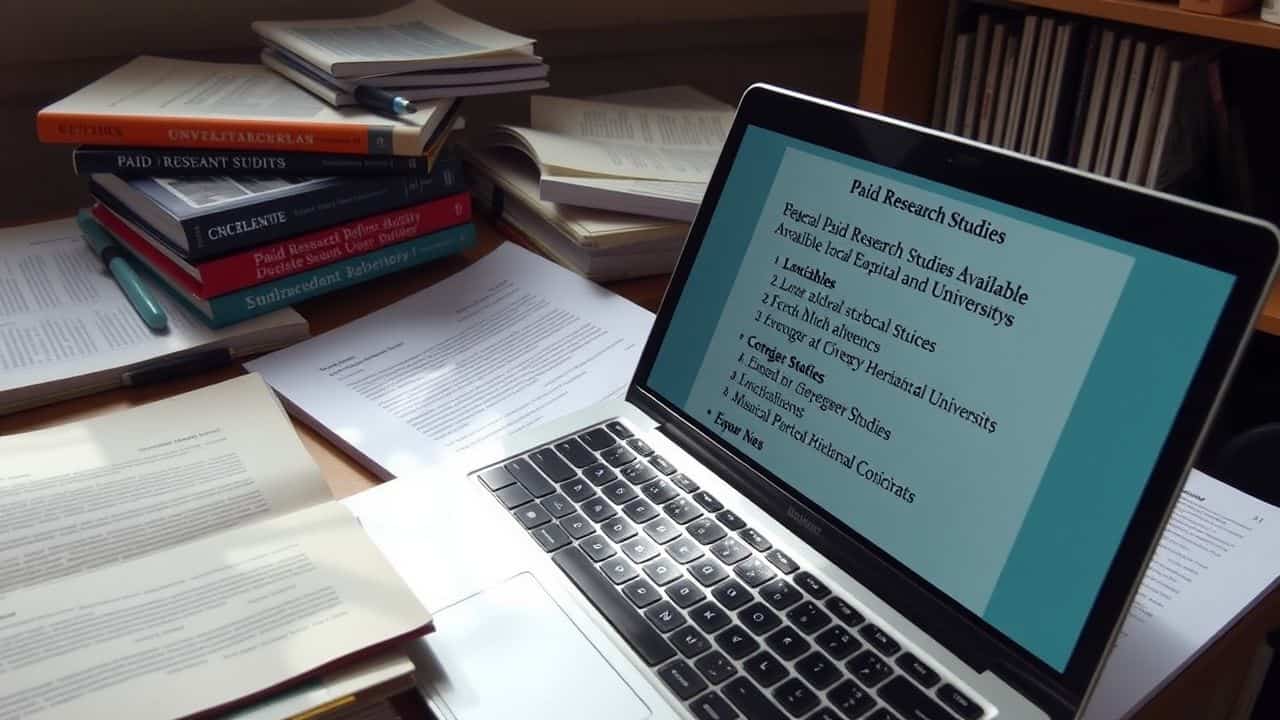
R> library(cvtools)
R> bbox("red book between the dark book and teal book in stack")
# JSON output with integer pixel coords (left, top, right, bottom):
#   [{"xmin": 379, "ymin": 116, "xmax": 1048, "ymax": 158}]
[{"xmin": 93, "ymin": 192, "xmax": 471, "ymax": 300}]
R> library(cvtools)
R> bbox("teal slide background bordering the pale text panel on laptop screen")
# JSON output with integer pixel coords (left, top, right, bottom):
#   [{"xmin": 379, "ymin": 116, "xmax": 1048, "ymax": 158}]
[{"xmin": 649, "ymin": 127, "xmax": 1231, "ymax": 669}]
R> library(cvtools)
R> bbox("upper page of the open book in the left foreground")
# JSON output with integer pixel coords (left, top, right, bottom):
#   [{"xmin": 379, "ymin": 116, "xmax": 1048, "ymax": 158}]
[{"xmin": 0, "ymin": 375, "xmax": 332, "ymax": 594}]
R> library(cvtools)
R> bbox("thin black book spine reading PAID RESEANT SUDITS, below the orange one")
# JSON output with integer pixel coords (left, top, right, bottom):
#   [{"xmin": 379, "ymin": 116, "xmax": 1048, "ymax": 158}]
[{"xmin": 72, "ymin": 146, "xmax": 430, "ymax": 177}]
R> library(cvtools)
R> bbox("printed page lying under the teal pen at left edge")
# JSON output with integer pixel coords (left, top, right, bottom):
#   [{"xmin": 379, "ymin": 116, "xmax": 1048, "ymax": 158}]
[{"xmin": 0, "ymin": 218, "xmax": 307, "ymax": 412}]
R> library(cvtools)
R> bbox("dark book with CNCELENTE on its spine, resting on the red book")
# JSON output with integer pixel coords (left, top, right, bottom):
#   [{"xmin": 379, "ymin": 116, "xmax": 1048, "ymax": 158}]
[{"xmin": 90, "ymin": 155, "xmax": 466, "ymax": 260}]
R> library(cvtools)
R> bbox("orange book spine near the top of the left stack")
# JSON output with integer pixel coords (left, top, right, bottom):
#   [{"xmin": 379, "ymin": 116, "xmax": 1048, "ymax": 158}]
[{"xmin": 36, "ymin": 110, "xmax": 396, "ymax": 155}]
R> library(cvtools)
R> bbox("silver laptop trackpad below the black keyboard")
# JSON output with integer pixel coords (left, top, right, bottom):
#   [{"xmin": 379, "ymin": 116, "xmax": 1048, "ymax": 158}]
[{"xmin": 413, "ymin": 573, "xmax": 650, "ymax": 720}]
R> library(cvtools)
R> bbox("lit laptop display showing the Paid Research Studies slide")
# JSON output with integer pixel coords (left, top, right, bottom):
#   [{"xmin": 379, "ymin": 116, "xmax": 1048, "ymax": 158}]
[{"xmin": 644, "ymin": 126, "xmax": 1234, "ymax": 671}]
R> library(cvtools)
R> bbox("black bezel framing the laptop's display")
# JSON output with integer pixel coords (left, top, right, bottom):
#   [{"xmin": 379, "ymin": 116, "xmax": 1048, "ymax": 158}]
[{"xmin": 627, "ymin": 85, "xmax": 1277, "ymax": 717}]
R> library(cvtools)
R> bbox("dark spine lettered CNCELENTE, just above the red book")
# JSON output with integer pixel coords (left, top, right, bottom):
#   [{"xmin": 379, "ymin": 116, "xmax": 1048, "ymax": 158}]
[{"xmin": 182, "ymin": 159, "xmax": 463, "ymax": 261}]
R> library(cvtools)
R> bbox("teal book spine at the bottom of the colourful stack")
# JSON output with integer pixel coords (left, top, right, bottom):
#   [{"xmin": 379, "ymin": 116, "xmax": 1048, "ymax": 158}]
[{"xmin": 197, "ymin": 223, "xmax": 476, "ymax": 328}]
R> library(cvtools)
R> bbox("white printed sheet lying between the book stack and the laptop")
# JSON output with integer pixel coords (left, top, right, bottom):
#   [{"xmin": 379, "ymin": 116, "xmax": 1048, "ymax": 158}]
[{"xmin": 246, "ymin": 243, "xmax": 653, "ymax": 478}]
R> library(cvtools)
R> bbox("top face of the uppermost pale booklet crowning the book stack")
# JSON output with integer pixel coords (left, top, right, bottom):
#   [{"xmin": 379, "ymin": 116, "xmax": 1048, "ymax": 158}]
[{"xmin": 252, "ymin": 0, "xmax": 534, "ymax": 77}]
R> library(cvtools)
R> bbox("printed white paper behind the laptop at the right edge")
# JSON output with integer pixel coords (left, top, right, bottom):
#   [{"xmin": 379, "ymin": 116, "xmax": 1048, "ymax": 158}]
[{"xmin": 1083, "ymin": 470, "xmax": 1280, "ymax": 720}]
